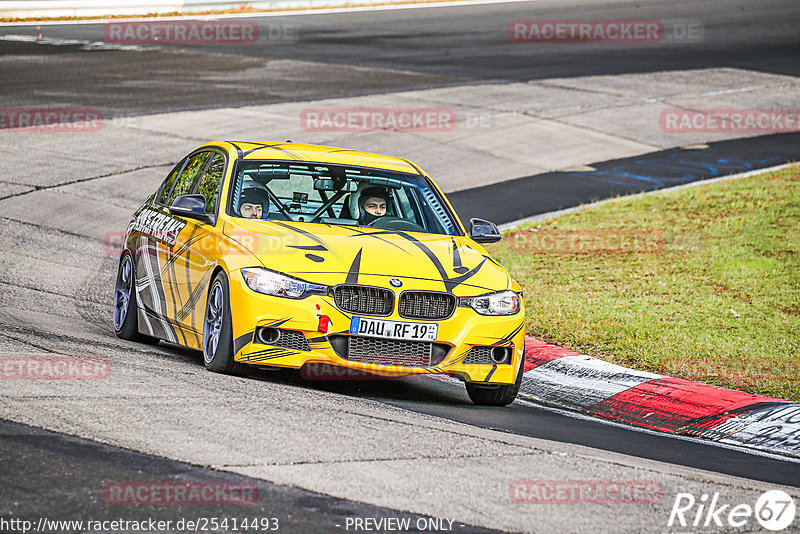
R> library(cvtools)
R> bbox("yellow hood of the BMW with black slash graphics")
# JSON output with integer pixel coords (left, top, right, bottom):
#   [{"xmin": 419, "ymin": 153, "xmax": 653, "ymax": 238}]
[{"xmin": 223, "ymin": 219, "xmax": 519, "ymax": 296}]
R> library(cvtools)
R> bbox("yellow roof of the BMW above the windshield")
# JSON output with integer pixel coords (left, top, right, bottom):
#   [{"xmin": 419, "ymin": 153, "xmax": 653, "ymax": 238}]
[{"xmin": 204, "ymin": 141, "xmax": 420, "ymax": 175}]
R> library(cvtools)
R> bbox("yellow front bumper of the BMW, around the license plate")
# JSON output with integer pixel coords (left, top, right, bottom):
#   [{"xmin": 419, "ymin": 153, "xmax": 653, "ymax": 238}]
[{"xmin": 231, "ymin": 273, "xmax": 525, "ymax": 384}]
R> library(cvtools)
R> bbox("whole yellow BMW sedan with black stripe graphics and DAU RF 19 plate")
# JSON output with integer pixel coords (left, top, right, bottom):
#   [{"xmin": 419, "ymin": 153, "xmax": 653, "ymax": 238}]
[{"xmin": 114, "ymin": 141, "xmax": 525, "ymax": 405}]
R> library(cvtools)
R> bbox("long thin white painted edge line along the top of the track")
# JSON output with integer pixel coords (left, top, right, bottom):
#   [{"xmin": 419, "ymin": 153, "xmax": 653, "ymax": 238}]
[{"xmin": 0, "ymin": 0, "xmax": 538, "ymax": 28}]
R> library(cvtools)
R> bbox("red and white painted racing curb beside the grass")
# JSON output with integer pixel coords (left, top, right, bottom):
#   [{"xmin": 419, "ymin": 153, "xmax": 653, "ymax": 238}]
[{"xmin": 520, "ymin": 337, "xmax": 800, "ymax": 458}]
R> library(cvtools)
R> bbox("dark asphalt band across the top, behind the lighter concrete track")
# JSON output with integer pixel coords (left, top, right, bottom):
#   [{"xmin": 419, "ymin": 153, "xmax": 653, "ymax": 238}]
[{"xmin": 0, "ymin": 0, "xmax": 800, "ymax": 115}]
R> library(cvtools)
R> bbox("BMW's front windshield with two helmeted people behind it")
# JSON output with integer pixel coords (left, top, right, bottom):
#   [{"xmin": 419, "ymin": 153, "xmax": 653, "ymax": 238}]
[{"xmin": 228, "ymin": 161, "xmax": 459, "ymax": 235}]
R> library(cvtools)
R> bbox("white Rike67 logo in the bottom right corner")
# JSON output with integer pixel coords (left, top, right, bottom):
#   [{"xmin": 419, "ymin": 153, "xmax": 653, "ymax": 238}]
[{"xmin": 667, "ymin": 490, "xmax": 797, "ymax": 532}]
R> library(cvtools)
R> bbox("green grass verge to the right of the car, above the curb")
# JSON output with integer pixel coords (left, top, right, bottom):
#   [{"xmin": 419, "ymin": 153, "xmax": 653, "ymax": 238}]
[{"xmin": 488, "ymin": 166, "xmax": 800, "ymax": 401}]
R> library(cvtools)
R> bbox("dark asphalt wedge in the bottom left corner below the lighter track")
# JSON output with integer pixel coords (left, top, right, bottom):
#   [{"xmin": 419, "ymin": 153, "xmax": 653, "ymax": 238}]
[{"xmin": 0, "ymin": 421, "xmax": 492, "ymax": 533}]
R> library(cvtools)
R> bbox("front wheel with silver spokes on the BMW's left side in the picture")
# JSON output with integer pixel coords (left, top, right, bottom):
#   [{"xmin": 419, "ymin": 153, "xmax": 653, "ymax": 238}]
[{"xmin": 203, "ymin": 271, "xmax": 249, "ymax": 376}]
